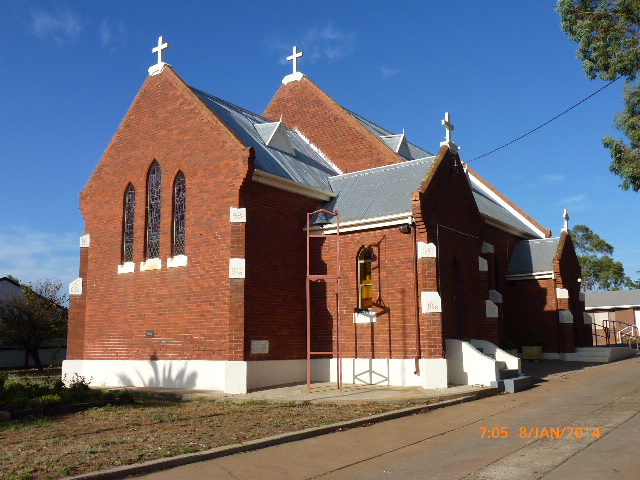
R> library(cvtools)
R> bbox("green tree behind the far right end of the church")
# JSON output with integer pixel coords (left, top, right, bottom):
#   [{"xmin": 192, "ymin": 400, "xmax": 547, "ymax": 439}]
[{"xmin": 571, "ymin": 225, "xmax": 635, "ymax": 291}]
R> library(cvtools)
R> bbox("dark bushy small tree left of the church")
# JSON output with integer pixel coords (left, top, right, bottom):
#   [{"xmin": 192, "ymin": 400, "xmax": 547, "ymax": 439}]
[{"xmin": 0, "ymin": 280, "xmax": 67, "ymax": 370}]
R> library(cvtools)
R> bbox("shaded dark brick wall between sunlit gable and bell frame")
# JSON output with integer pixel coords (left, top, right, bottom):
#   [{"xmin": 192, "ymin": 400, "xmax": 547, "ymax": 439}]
[{"xmin": 241, "ymin": 182, "xmax": 320, "ymax": 360}]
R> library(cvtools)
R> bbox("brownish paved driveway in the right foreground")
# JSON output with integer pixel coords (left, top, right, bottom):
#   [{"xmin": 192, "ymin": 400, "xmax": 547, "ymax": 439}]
[{"xmin": 139, "ymin": 357, "xmax": 640, "ymax": 480}]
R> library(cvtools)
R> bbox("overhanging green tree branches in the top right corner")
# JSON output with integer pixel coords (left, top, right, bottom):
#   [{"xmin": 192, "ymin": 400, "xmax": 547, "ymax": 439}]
[{"xmin": 556, "ymin": 0, "xmax": 640, "ymax": 192}]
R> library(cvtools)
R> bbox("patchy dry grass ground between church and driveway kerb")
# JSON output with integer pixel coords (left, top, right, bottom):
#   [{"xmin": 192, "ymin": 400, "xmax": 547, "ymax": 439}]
[{"xmin": 0, "ymin": 398, "xmax": 408, "ymax": 480}]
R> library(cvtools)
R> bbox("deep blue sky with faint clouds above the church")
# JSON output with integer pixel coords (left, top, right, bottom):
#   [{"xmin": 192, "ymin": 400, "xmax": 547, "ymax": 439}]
[{"xmin": 0, "ymin": 0, "xmax": 640, "ymax": 290}]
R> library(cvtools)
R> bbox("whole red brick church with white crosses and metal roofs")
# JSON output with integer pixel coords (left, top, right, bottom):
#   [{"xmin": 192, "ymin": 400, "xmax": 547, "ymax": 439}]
[{"xmin": 63, "ymin": 37, "xmax": 591, "ymax": 393}]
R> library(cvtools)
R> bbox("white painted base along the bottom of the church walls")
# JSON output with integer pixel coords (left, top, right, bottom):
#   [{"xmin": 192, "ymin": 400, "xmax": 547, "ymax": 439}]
[{"xmin": 62, "ymin": 358, "xmax": 447, "ymax": 394}]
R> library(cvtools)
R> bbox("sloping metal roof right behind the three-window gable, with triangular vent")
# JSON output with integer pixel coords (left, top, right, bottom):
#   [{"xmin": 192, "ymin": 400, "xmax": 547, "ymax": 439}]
[{"xmin": 191, "ymin": 88, "xmax": 339, "ymax": 191}]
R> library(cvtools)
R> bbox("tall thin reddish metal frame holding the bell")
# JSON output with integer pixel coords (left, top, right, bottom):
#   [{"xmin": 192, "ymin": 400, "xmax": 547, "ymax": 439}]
[{"xmin": 307, "ymin": 209, "xmax": 342, "ymax": 392}]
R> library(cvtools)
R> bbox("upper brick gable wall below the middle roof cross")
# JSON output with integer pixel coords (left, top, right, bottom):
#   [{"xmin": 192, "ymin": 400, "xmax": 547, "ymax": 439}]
[{"xmin": 264, "ymin": 77, "xmax": 403, "ymax": 173}]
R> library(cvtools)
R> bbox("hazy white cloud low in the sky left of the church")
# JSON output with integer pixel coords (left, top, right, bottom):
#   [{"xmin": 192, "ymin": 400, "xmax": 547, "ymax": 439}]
[{"xmin": 0, "ymin": 226, "xmax": 80, "ymax": 285}]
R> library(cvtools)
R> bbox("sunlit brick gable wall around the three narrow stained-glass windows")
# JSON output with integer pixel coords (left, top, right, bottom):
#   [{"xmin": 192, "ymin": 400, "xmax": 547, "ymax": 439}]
[{"xmin": 70, "ymin": 67, "xmax": 251, "ymax": 360}]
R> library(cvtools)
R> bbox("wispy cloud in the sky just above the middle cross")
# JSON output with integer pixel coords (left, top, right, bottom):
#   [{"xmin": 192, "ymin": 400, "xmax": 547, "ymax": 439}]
[{"xmin": 270, "ymin": 23, "xmax": 357, "ymax": 64}]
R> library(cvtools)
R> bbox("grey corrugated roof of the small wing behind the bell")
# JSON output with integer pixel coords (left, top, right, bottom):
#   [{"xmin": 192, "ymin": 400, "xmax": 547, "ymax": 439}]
[{"xmin": 322, "ymin": 157, "xmax": 435, "ymax": 223}]
